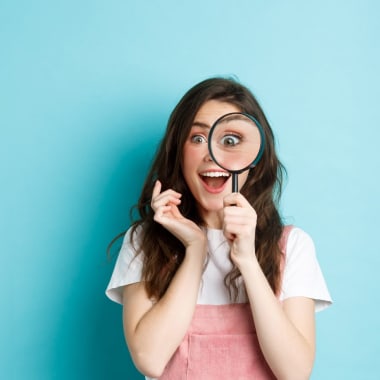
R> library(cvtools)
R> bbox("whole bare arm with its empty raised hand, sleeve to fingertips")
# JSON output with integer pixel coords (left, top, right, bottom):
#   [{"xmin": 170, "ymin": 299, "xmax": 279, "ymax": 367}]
[{"xmin": 123, "ymin": 185, "xmax": 207, "ymax": 377}]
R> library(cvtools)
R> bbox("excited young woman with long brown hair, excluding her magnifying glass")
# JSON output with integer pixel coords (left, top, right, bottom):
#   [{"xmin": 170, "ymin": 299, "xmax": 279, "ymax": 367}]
[{"xmin": 107, "ymin": 78, "xmax": 331, "ymax": 380}]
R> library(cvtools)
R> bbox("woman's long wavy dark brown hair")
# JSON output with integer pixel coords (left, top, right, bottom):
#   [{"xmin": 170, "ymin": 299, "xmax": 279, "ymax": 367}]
[{"xmin": 115, "ymin": 78, "xmax": 285, "ymax": 300}]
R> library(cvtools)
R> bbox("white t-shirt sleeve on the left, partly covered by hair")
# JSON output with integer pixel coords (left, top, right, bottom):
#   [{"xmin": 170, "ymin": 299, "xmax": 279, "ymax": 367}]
[{"xmin": 106, "ymin": 229, "xmax": 143, "ymax": 304}]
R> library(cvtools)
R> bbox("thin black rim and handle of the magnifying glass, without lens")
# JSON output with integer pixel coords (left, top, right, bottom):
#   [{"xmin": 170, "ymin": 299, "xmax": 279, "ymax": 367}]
[{"xmin": 207, "ymin": 112, "xmax": 265, "ymax": 193}]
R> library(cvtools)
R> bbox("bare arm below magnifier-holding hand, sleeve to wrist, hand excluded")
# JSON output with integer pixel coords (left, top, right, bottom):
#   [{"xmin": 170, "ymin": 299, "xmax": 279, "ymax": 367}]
[{"xmin": 241, "ymin": 260, "xmax": 315, "ymax": 380}]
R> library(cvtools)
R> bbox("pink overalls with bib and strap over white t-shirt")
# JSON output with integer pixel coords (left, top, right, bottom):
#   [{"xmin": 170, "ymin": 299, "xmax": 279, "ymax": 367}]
[{"xmin": 160, "ymin": 226, "xmax": 291, "ymax": 380}]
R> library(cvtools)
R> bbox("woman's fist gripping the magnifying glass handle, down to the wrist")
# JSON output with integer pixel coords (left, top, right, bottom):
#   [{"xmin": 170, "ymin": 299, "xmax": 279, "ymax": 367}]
[{"xmin": 223, "ymin": 193, "xmax": 257, "ymax": 268}]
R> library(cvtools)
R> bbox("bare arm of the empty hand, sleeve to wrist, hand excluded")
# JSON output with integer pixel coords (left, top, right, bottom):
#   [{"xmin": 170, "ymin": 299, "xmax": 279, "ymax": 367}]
[{"xmin": 123, "ymin": 240, "xmax": 203, "ymax": 377}]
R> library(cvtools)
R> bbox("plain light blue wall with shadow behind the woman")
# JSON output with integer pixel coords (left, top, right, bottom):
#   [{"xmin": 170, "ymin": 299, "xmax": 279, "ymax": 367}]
[{"xmin": 0, "ymin": 0, "xmax": 380, "ymax": 380}]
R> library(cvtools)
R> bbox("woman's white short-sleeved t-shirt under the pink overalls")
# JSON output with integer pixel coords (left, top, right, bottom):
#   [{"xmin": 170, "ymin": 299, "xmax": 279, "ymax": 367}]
[{"xmin": 106, "ymin": 227, "xmax": 332, "ymax": 311}]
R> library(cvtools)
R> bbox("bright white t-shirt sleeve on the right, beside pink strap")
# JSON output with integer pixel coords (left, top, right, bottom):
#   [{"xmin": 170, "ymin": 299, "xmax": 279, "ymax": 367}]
[{"xmin": 280, "ymin": 228, "xmax": 332, "ymax": 311}]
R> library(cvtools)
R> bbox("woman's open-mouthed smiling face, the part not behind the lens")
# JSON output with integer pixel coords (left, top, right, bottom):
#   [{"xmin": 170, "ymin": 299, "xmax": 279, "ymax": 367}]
[{"xmin": 182, "ymin": 100, "xmax": 248, "ymax": 228}]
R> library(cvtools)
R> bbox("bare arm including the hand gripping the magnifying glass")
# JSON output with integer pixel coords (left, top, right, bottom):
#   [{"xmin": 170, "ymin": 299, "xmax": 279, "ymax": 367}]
[{"xmin": 224, "ymin": 194, "xmax": 315, "ymax": 380}]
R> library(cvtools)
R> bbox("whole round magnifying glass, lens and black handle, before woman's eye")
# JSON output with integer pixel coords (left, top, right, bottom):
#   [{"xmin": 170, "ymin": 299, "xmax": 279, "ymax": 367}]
[{"xmin": 208, "ymin": 112, "xmax": 265, "ymax": 192}]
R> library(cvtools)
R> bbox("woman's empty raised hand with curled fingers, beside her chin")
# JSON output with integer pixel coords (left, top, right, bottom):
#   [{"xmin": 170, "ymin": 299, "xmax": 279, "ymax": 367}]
[{"xmin": 151, "ymin": 180, "xmax": 206, "ymax": 248}]
